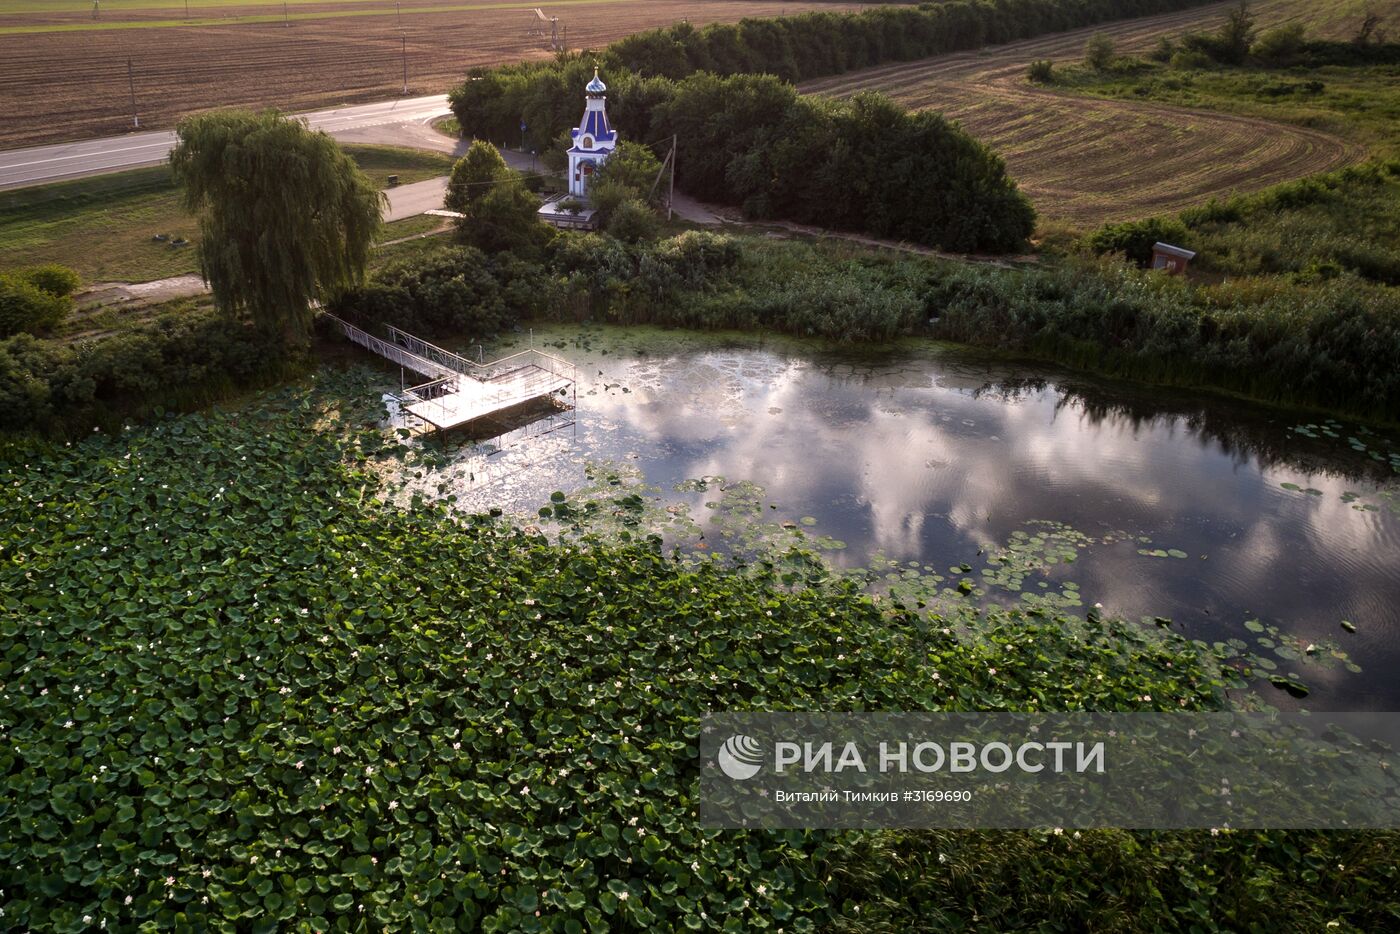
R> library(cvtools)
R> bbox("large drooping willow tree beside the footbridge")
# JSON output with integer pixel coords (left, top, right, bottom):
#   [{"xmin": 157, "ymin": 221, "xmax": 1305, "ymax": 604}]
[{"xmin": 171, "ymin": 111, "xmax": 386, "ymax": 344}]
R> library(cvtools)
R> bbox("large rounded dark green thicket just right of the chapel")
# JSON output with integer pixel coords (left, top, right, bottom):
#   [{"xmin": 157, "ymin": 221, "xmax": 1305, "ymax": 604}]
[{"xmin": 644, "ymin": 74, "xmax": 1035, "ymax": 252}]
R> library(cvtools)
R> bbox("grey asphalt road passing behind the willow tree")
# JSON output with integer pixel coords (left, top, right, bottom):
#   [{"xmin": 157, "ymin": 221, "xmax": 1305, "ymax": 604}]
[{"xmin": 0, "ymin": 94, "xmax": 451, "ymax": 189}]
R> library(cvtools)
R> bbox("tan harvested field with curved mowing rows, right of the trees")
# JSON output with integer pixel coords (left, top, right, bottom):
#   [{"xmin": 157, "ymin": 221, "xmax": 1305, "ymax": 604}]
[{"xmin": 802, "ymin": 0, "xmax": 1365, "ymax": 227}]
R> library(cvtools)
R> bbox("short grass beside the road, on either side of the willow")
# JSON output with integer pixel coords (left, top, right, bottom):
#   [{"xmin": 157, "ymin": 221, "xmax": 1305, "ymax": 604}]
[{"xmin": 0, "ymin": 146, "xmax": 452, "ymax": 283}]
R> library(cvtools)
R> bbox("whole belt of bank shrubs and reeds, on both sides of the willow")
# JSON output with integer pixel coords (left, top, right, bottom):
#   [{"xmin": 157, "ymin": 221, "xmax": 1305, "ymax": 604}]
[{"xmin": 8, "ymin": 211, "xmax": 1400, "ymax": 434}]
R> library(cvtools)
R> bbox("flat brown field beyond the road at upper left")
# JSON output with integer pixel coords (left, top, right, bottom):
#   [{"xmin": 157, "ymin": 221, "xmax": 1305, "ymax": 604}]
[{"xmin": 0, "ymin": 0, "xmax": 858, "ymax": 148}]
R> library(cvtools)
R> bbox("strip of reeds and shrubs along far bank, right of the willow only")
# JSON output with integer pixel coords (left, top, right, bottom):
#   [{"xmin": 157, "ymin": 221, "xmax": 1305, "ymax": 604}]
[{"xmin": 332, "ymin": 211, "xmax": 1383, "ymax": 423}]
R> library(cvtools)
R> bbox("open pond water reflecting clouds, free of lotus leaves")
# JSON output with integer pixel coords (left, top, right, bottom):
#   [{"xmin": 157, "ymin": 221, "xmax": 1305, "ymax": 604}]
[{"xmin": 383, "ymin": 326, "xmax": 1400, "ymax": 710}]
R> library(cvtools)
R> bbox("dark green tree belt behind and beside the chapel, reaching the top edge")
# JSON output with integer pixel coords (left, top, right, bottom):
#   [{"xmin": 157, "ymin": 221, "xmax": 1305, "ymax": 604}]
[{"xmin": 451, "ymin": 0, "xmax": 1203, "ymax": 252}]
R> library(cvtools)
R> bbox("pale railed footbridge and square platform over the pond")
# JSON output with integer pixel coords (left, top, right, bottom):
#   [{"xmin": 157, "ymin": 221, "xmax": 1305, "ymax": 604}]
[{"xmin": 322, "ymin": 312, "xmax": 577, "ymax": 430}]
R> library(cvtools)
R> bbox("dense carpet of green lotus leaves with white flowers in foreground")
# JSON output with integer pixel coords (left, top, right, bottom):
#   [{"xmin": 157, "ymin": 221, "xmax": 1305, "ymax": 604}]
[{"xmin": 0, "ymin": 371, "xmax": 1400, "ymax": 931}]
